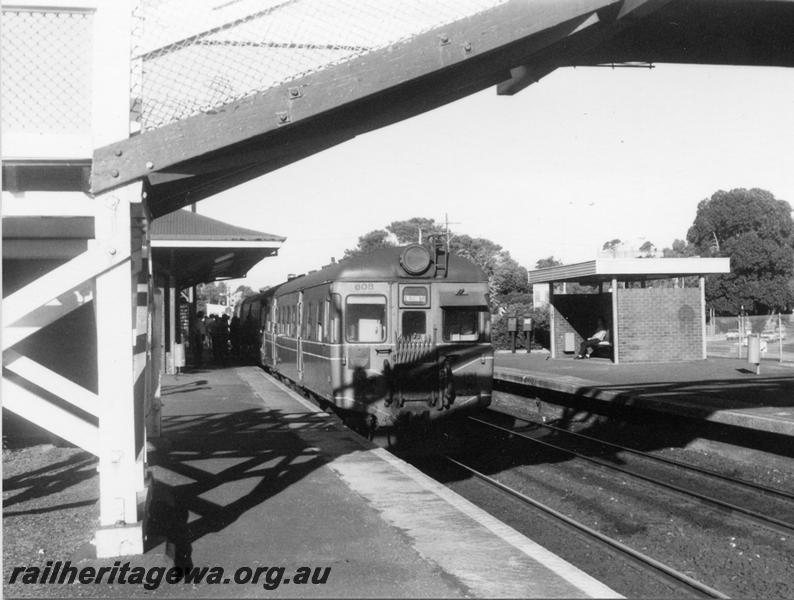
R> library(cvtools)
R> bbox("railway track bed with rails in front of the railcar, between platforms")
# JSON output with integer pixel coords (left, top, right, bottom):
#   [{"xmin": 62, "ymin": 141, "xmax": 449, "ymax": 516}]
[{"xmin": 396, "ymin": 411, "xmax": 794, "ymax": 598}]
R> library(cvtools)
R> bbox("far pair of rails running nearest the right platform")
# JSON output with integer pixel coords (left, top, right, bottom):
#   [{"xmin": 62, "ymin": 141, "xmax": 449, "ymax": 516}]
[{"xmin": 469, "ymin": 413, "xmax": 794, "ymax": 536}]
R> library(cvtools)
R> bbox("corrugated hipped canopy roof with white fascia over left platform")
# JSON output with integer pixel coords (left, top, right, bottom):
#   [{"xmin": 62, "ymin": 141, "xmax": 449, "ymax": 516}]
[{"xmin": 151, "ymin": 210, "xmax": 287, "ymax": 288}]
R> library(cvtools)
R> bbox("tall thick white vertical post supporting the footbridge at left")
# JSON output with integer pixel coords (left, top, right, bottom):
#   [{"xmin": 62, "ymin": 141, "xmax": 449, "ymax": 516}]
[{"xmin": 91, "ymin": 0, "xmax": 149, "ymax": 557}]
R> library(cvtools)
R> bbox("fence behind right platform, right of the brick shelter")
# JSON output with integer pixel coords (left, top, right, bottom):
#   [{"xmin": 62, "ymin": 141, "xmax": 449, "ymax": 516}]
[{"xmin": 706, "ymin": 314, "xmax": 794, "ymax": 362}]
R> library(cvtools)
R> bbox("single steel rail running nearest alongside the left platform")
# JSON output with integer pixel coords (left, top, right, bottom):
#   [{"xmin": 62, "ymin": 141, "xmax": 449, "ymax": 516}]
[{"xmin": 444, "ymin": 456, "xmax": 729, "ymax": 598}]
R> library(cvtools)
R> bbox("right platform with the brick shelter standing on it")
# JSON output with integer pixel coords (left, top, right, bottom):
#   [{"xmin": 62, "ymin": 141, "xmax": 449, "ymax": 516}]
[{"xmin": 494, "ymin": 351, "xmax": 794, "ymax": 436}]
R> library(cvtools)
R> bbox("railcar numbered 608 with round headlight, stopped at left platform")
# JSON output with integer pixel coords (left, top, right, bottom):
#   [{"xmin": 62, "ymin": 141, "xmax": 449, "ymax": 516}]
[{"xmin": 237, "ymin": 241, "xmax": 493, "ymax": 430}]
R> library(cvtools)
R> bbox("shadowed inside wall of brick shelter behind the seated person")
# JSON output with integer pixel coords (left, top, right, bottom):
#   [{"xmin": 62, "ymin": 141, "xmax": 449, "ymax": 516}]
[{"xmin": 552, "ymin": 294, "xmax": 612, "ymax": 358}]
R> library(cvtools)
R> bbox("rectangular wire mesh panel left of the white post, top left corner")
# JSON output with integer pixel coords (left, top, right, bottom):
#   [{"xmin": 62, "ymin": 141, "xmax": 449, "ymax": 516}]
[{"xmin": 0, "ymin": 8, "xmax": 93, "ymax": 135}]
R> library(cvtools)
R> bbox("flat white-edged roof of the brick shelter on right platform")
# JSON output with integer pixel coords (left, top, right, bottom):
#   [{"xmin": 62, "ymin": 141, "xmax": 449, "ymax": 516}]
[{"xmin": 529, "ymin": 258, "xmax": 731, "ymax": 285}]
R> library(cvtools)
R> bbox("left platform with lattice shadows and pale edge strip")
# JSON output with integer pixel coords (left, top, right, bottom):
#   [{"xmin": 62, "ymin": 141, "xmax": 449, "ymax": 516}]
[{"xmin": 149, "ymin": 367, "xmax": 620, "ymax": 598}]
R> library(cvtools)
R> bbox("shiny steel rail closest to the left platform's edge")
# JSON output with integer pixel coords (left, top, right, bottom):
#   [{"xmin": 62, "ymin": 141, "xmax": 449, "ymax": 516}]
[{"xmin": 444, "ymin": 456, "xmax": 730, "ymax": 598}]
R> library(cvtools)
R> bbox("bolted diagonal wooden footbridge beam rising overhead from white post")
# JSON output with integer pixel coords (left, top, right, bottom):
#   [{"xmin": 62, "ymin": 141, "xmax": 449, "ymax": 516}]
[{"xmin": 91, "ymin": 0, "xmax": 622, "ymax": 203}]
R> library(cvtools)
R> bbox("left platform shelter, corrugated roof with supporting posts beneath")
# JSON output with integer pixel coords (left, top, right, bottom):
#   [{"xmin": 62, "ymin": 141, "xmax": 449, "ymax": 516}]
[{"xmin": 150, "ymin": 210, "xmax": 286, "ymax": 373}]
